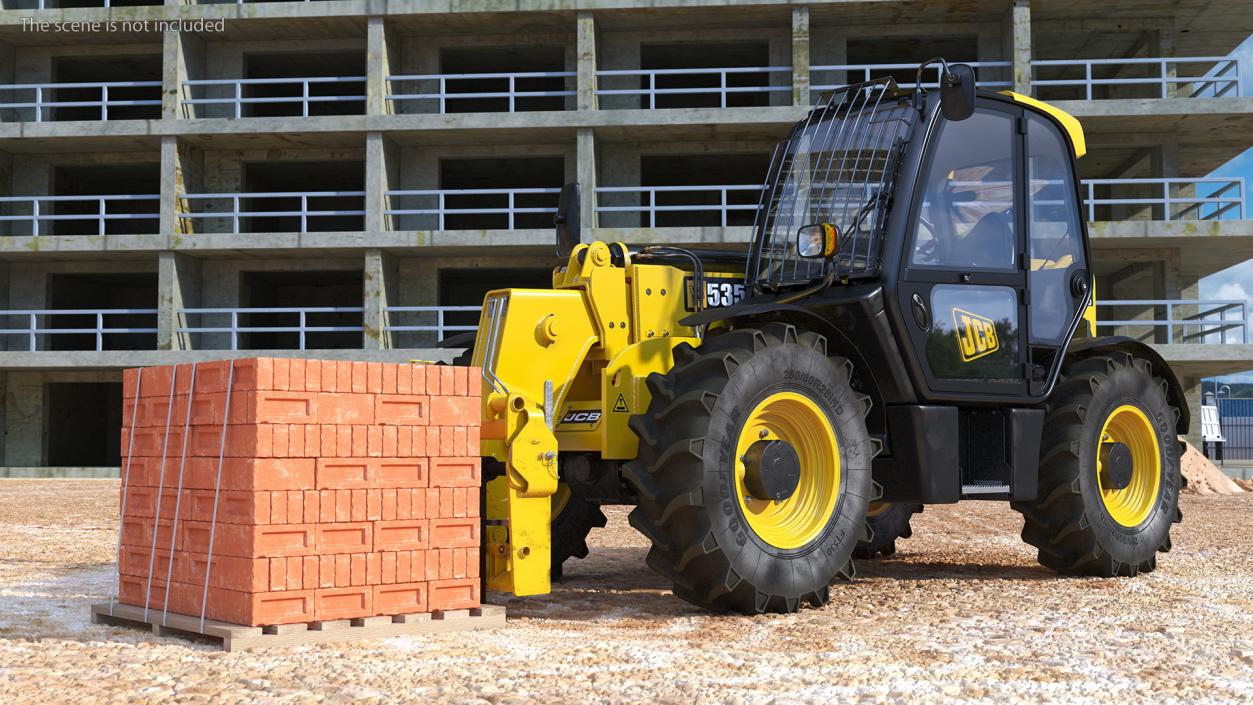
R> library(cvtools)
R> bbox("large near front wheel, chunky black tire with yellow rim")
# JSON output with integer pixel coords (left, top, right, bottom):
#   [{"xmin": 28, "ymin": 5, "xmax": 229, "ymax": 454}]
[{"xmin": 623, "ymin": 323, "xmax": 873, "ymax": 614}]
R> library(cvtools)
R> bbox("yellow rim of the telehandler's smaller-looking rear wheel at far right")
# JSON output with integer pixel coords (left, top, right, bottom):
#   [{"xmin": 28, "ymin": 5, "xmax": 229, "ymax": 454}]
[{"xmin": 1096, "ymin": 404, "xmax": 1162, "ymax": 527}]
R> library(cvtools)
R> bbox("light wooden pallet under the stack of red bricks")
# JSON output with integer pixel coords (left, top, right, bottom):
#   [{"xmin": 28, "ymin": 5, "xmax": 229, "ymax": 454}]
[{"xmin": 91, "ymin": 602, "xmax": 505, "ymax": 651}]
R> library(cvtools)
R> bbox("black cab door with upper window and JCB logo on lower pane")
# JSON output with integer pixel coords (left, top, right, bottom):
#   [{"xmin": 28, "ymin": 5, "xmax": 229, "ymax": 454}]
[{"xmin": 897, "ymin": 99, "xmax": 1029, "ymax": 399}]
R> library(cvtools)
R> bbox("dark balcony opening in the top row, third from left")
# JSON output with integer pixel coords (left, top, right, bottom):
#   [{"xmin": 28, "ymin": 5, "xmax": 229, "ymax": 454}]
[{"xmin": 436, "ymin": 45, "xmax": 563, "ymax": 113}]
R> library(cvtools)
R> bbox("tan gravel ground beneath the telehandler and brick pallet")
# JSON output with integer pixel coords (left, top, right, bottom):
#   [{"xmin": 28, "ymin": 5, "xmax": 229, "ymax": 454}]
[{"xmin": 0, "ymin": 480, "xmax": 1253, "ymax": 705}]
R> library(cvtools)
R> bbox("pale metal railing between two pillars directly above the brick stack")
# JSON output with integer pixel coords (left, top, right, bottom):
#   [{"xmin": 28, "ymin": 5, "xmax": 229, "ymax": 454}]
[{"xmin": 178, "ymin": 306, "xmax": 365, "ymax": 351}]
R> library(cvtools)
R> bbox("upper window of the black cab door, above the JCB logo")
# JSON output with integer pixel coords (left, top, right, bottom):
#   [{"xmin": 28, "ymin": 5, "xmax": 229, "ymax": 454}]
[{"xmin": 911, "ymin": 110, "xmax": 1017, "ymax": 270}]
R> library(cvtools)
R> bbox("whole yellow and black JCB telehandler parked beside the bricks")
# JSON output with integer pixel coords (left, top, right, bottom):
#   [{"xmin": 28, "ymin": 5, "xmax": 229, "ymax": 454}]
[{"xmin": 461, "ymin": 60, "xmax": 1188, "ymax": 612}]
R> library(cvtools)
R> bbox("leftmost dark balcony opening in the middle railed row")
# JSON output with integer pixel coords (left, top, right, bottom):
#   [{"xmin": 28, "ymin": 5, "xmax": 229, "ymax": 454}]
[{"xmin": 50, "ymin": 164, "xmax": 160, "ymax": 235}]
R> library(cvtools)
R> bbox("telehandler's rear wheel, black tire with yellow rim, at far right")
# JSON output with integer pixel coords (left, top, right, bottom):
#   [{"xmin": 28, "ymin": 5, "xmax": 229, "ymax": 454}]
[{"xmin": 1014, "ymin": 352, "xmax": 1183, "ymax": 577}]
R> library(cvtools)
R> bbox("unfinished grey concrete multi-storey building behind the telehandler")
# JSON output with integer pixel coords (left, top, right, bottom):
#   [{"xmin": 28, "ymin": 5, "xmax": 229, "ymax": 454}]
[{"xmin": 0, "ymin": 0, "xmax": 1253, "ymax": 472}]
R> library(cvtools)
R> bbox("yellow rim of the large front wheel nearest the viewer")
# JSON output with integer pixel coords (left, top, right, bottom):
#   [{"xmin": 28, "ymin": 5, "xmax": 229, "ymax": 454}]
[{"xmin": 736, "ymin": 392, "xmax": 840, "ymax": 550}]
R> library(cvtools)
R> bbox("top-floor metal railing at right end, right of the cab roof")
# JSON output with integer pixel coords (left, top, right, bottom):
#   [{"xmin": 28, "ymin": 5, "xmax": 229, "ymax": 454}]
[{"xmin": 1031, "ymin": 56, "xmax": 1240, "ymax": 100}]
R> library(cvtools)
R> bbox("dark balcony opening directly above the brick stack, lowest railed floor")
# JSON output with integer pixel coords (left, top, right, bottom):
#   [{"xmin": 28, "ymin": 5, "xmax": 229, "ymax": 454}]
[{"xmin": 238, "ymin": 270, "xmax": 363, "ymax": 351}]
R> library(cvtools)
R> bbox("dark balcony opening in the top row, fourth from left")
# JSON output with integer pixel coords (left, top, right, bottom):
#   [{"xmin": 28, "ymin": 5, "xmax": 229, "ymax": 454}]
[{"xmin": 646, "ymin": 40, "xmax": 771, "ymax": 108}]
